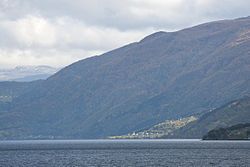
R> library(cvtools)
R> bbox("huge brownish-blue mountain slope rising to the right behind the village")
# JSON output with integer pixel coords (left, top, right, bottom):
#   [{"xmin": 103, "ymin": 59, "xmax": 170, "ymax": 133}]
[{"xmin": 0, "ymin": 17, "xmax": 250, "ymax": 139}]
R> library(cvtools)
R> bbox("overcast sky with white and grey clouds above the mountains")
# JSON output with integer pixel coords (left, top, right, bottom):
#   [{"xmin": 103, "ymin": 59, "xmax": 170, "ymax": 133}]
[{"xmin": 0, "ymin": 0, "xmax": 250, "ymax": 69}]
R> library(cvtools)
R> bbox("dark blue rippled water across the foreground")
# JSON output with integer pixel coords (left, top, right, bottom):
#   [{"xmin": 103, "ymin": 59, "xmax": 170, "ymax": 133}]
[{"xmin": 0, "ymin": 140, "xmax": 250, "ymax": 167}]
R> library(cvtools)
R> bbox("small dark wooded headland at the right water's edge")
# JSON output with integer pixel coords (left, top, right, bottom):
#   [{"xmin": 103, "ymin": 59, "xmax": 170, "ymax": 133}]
[{"xmin": 203, "ymin": 123, "xmax": 250, "ymax": 140}]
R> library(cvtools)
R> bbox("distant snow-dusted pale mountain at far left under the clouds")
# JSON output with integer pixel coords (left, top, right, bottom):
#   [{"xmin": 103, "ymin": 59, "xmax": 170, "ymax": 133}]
[{"xmin": 0, "ymin": 66, "xmax": 59, "ymax": 82}]
